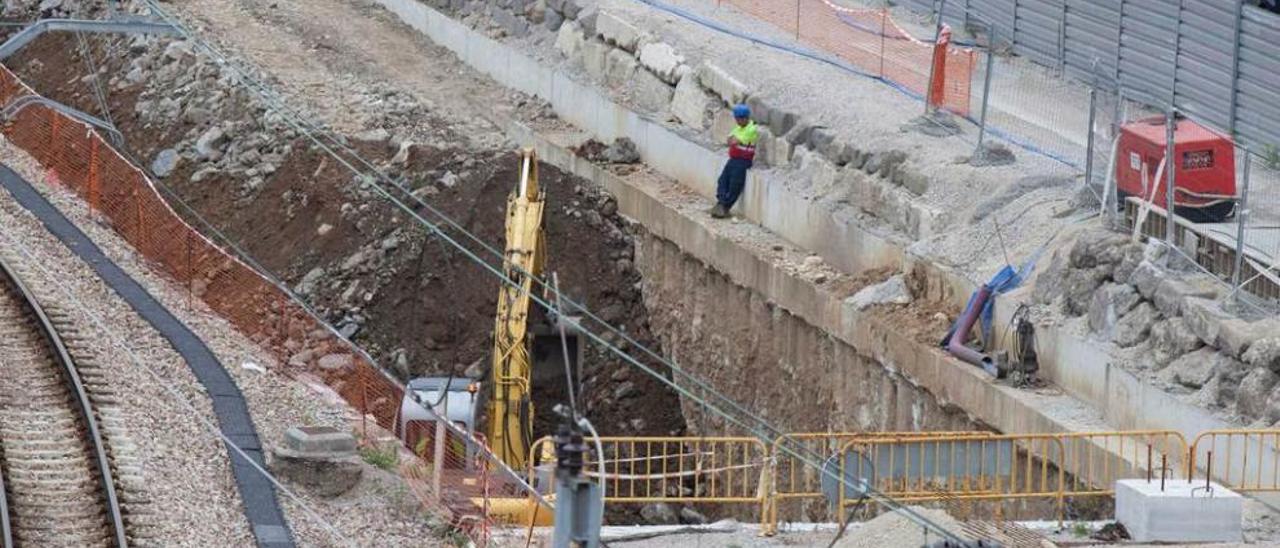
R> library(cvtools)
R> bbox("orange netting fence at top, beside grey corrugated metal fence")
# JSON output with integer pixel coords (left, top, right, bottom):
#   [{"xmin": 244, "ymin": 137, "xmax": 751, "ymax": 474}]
[{"xmin": 717, "ymin": 0, "xmax": 975, "ymax": 115}]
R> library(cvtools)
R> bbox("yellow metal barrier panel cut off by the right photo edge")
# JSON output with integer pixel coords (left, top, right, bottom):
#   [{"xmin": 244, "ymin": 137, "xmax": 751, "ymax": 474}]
[{"xmin": 1187, "ymin": 429, "xmax": 1280, "ymax": 493}]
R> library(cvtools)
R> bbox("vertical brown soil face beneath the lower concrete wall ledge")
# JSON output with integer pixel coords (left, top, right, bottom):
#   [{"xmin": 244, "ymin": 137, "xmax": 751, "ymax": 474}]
[{"xmin": 636, "ymin": 233, "xmax": 980, "ymax": 434}]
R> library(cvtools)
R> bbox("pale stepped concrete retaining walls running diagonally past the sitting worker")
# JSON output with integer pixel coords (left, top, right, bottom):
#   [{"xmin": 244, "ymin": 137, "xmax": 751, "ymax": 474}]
[{"xmin": 378, "ymin": 0, "xmax": 1269, "ymax": 501}]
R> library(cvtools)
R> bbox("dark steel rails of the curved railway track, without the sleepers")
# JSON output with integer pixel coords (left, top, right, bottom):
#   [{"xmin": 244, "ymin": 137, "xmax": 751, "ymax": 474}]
[{"xmin": 0, "ymin": 259, "xmax": 129, "ymax": 548}]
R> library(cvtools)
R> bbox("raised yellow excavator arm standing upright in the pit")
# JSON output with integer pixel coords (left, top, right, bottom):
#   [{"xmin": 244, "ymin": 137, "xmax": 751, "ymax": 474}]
[{"xmin": 488, "ymin": 149, "xmax": 547, "ymax": 470}]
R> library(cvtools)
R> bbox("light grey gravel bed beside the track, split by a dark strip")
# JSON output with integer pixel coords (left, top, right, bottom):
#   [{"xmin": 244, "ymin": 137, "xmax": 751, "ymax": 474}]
[{"xmin": 0, "ymin": 141, "xmax": 434, "ymax": 545}]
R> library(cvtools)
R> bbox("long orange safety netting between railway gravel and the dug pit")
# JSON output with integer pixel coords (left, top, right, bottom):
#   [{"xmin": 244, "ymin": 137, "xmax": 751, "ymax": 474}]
[{"xmin": 0, "ymin": 67, "xmax": 540, "ymax": 544}]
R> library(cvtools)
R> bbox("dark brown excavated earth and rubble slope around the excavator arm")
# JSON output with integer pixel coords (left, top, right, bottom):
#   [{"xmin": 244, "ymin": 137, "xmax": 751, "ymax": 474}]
[{"xmin": 9, "ymin": 35, "xmax": 685, "ymax": 435}]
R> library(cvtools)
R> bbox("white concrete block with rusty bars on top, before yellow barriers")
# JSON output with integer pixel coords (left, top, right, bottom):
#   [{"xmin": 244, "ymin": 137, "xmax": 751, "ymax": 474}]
[{"xmin": 1116, "ymin": 479, "xmax": 1244, "ymax": 543}]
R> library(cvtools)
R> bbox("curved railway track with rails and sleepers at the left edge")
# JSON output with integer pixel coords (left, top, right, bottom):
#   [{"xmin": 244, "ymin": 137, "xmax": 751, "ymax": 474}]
[{"xmin": 0, "ymin": 257, "xmax": 129, "ymax": 548}]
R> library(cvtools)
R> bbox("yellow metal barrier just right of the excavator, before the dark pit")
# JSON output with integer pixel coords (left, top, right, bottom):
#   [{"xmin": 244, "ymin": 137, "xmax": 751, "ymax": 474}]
[{"xmin": 529, "ymin": 437, "xmax": 769, "ymax": 516}]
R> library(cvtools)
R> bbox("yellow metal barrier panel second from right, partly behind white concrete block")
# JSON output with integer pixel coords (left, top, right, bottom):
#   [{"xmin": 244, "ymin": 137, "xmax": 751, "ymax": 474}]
[{"xmin": 1056, "ymin": 430, "xmax": 1188, "ymax": 497}]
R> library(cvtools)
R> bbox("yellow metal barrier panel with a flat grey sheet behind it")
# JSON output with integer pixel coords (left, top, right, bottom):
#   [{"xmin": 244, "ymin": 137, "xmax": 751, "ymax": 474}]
[{"xmin": 837, "ymin": 434, "xmax": 1065, "ymax": 522}]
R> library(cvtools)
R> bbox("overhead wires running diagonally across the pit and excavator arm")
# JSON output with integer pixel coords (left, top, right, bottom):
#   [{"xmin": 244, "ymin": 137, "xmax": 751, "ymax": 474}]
[{"xmin": 102, "ymin": 0, "xmax": 959, "ymax": 539}]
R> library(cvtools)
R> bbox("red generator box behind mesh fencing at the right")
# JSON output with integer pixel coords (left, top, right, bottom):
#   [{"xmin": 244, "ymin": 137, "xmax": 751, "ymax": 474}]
[{"xmin": 1116, "ymin": 117, "xmax": 1236, "ymax": 223}]
